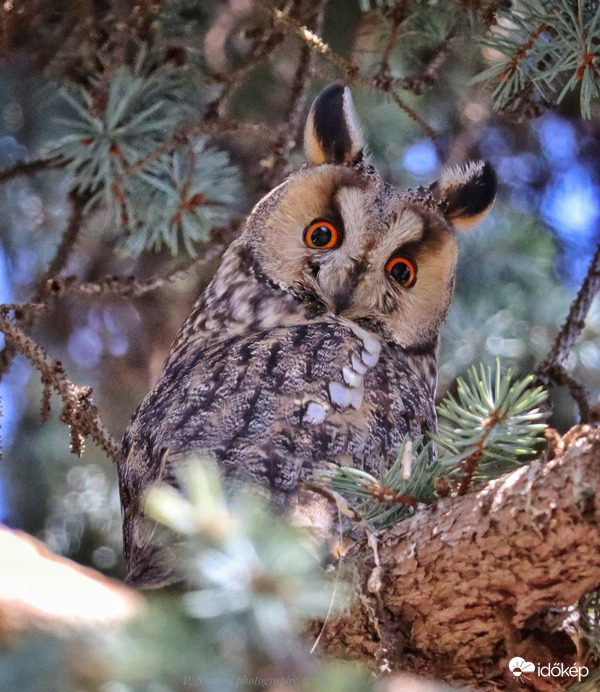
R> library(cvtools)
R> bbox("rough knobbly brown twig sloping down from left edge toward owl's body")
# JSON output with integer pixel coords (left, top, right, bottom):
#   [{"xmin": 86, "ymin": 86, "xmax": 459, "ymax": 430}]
[{"xmin": 0, "ymin": 314, "xmax": 121, "ymax": 463}]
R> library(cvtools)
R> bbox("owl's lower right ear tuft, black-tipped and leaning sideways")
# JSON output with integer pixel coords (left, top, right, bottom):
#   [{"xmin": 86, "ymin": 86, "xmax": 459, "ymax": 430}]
[{"xmin": 430, "ymin": 161, "xmax": 497, "ymax": 229}]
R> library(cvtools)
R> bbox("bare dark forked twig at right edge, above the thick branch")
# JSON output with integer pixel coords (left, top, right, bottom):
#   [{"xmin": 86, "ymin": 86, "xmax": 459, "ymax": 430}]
[{"xmin": 534, "ymin": 238, "xmax": 600, "ymax": 423}]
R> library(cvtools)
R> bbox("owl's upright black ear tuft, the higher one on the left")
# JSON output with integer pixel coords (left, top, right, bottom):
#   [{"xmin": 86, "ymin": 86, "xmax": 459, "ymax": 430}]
[{"xmin": 304, "ymin": 84, "xmax": 363, "ymax": 164}]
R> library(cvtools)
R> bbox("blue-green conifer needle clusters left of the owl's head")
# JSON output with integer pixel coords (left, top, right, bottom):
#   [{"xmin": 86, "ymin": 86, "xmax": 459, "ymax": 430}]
[{"xmin": 45, "ymin": 58, "xmax": 240, "ymax": 255}]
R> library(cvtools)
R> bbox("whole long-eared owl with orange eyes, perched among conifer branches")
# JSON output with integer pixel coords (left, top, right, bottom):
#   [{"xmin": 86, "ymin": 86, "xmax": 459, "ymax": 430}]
[{"xmin": 119, "ymin": 84, "xmax": 496, "ymax": 586}]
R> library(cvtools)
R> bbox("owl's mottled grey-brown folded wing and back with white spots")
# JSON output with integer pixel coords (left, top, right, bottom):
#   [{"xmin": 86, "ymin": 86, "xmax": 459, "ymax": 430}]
[{"xmin": 119, "ymin": 318, "xmax": 435, "ymax": 584}]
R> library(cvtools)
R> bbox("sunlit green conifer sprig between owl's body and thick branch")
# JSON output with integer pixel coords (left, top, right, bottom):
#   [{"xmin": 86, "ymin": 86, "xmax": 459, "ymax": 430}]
[{"xmin": 315, "ymin": 361, "xmax": 548, "ymax": 529}]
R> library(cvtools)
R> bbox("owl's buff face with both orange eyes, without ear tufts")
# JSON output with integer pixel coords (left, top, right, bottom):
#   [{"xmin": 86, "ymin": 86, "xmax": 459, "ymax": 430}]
[{"xmin": 248, "ymin": 164, "xmax": 464, "ymax": 346}]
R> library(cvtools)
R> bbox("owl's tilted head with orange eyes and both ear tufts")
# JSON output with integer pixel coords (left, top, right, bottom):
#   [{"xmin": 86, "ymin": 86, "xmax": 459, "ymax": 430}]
[{"xmin": 243, "ymin": 84, "xmax": 496, "ymax": 348}]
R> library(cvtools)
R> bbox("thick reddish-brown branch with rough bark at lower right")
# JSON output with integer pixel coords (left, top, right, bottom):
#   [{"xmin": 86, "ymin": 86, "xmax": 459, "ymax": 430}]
[{"xmin": 315, "ymin": 426, "xmax": 600, "ymax": 691}]
